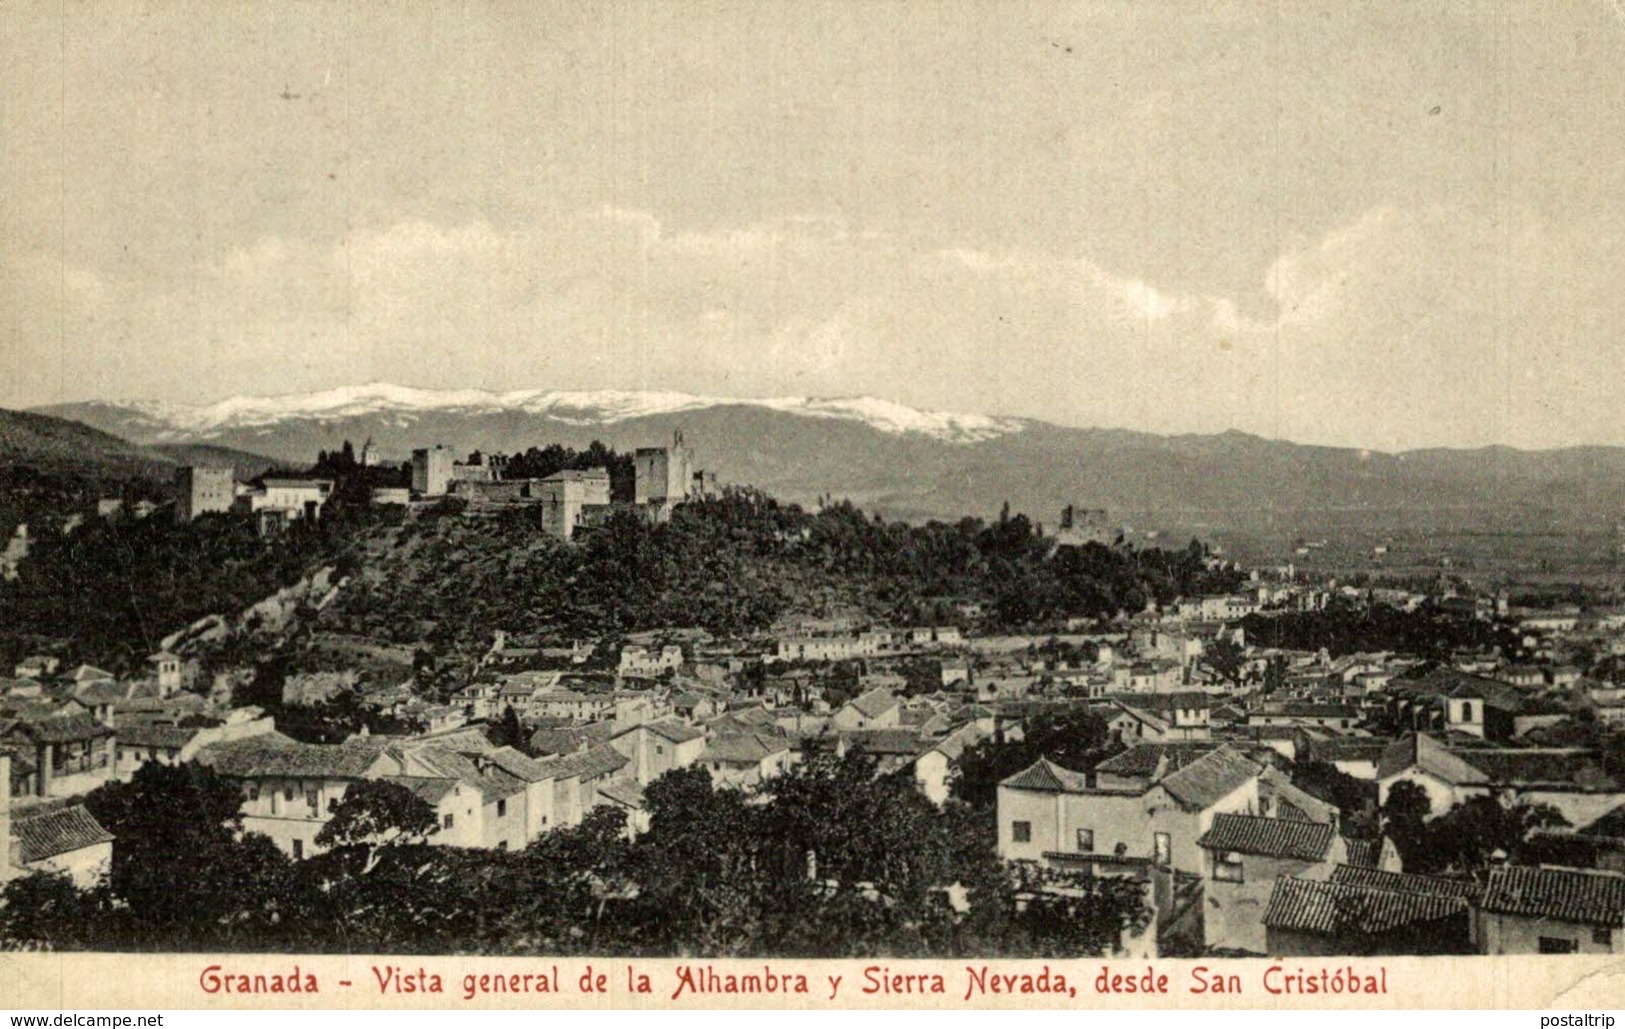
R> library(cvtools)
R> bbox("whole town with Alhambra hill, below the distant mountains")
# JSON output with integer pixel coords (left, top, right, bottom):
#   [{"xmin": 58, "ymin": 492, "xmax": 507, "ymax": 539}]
[{"xmin": 0, "ymin": 431, "xmax": 1625, "ymax": 957}]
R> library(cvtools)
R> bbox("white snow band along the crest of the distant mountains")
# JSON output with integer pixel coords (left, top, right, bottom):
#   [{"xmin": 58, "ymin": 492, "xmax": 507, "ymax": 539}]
[{"xmin": 95, "ymin": 382, "xmax": 1025, "ymax": 442}]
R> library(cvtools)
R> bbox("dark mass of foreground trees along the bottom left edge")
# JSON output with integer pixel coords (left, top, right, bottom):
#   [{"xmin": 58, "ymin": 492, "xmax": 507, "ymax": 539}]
[{"xmin": 0, "ymin": 756, "xmax": 1146, "ymax": 957}]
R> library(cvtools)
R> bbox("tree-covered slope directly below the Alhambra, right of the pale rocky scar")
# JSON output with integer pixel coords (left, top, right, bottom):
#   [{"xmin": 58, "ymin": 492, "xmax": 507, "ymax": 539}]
[{"xmin": 328, "ymin": 489, "xmax": 1237, "ymax": 645}]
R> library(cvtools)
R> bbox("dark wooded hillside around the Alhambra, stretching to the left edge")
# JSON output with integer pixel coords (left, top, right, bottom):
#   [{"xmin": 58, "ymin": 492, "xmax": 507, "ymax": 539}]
[{"xmin": 0, "ymin": 445, "xmax": 1237, "ymax": 678}]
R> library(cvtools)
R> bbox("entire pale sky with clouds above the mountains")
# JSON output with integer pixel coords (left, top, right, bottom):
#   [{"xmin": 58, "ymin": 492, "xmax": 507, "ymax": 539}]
[{"xmin": 0, "ymin": 0, "xmax": 1625, "ymax": 450}]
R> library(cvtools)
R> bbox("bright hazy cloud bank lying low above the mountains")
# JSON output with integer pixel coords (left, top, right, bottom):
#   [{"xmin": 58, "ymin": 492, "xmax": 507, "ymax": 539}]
[{"xmin": 7, "ymin": 206, "xmax": 1625, "ymax": 449}]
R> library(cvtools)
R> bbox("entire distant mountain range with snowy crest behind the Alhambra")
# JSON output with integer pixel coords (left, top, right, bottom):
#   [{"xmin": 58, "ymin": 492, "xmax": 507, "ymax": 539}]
[{"xmin": 31, "ymin": 385, "xmax": 1625, "ymax": 533}]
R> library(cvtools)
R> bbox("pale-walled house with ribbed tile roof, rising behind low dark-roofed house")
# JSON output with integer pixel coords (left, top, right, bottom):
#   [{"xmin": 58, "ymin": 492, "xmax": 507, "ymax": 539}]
[{"xmin": 1196, "ymin": 814, "xmax": 1347, "ymax": 954}]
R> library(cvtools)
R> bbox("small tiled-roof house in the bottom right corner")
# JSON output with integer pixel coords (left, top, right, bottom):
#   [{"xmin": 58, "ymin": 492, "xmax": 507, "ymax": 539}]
[{"xmin": 1479, "ymin": 865, "xmax": 1625, "ymax": 954}]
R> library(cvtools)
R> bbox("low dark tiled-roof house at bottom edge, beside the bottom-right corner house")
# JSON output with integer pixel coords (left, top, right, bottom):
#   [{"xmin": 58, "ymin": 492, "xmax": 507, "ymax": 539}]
[{"xmin": 1264, "ymin": 865, "xmax": 1477, "ymax": 957}]
